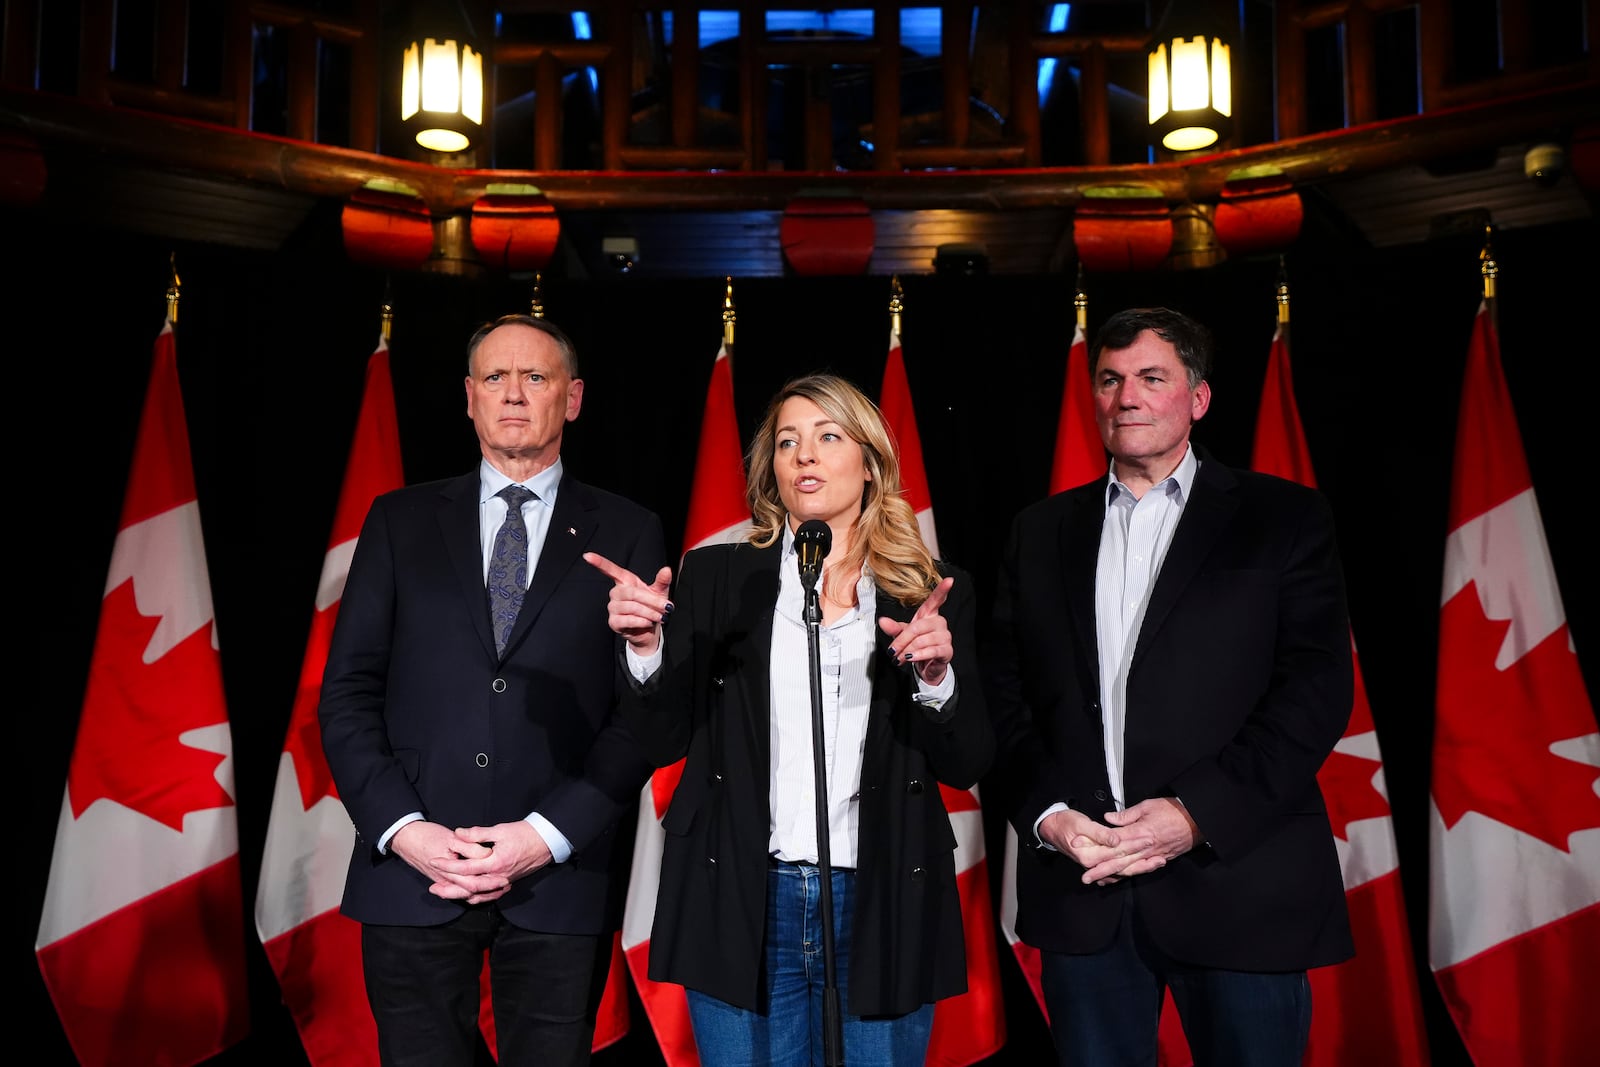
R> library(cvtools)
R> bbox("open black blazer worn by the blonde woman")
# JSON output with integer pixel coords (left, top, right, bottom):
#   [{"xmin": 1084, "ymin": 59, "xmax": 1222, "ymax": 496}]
[{"xmin": 622, "ymin": 544, "xmax": 994, "ymax": 1016}]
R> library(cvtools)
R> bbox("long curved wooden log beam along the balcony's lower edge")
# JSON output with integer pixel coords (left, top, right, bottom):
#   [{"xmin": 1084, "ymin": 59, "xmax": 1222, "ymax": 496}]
[{"xmin": 0, "ymin": 80, "xmax": 1600, "ymax": 216}]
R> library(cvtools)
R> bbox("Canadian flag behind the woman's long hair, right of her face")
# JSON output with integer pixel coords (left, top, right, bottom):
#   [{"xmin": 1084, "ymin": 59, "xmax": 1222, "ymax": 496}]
[{"xmin": 878, "ymin": 330, "xmax": 1005, "ymax": 1067}]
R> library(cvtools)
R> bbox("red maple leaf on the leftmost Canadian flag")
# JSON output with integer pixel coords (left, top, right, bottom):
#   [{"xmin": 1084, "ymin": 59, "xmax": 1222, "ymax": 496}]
[{"xmin": 67, "ymin": 581, "xmax": 234, "ymax": 832}]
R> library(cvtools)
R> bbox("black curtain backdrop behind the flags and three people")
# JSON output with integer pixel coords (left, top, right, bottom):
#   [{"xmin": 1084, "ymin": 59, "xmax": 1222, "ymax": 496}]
[{"xmin": 18, "ymin": 202, "xmax": 1600, "ymax": 1067}]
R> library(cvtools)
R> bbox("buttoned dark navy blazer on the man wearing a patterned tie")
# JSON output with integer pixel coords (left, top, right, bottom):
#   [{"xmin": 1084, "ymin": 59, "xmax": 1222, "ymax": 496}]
[{"xmin": 318, "ymin": 469, "xmax": 666, "ymax": 934}]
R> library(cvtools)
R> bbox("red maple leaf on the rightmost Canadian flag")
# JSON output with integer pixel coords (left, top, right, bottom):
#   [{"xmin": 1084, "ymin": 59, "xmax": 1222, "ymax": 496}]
[{"xmin": 1434, "ymin": 584, "xmax": 1600, "ymax": 851}]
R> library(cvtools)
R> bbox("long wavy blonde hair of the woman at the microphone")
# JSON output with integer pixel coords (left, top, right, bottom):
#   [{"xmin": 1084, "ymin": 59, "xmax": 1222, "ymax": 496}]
[{"xmin": 744, "ymin": 374, "xmax": 939, "ymax": 606}]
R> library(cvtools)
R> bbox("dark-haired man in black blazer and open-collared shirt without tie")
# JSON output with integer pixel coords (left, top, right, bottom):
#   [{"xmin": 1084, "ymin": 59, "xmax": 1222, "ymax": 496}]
[{"xmin": 990, "ymin": 309, "xmax": 1354, "ymax": 1067}]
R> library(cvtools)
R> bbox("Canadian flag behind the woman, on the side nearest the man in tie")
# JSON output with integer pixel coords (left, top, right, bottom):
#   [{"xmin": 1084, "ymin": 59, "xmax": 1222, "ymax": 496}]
[{"xmin": 622, "ymin": 341, "xmax": 750, "ymax": 1067}]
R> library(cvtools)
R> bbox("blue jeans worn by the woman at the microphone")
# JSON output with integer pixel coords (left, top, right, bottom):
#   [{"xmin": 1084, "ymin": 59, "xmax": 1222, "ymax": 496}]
[{"xmin": 688, "ymin": 864, "xmax": 933, "ymax": 1067}]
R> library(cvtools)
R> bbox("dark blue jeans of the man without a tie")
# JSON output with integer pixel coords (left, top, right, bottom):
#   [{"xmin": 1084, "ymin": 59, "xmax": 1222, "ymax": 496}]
[{"xmin": 1040, "ymin": 893, "xmax": 1310, "ymax": 1067}]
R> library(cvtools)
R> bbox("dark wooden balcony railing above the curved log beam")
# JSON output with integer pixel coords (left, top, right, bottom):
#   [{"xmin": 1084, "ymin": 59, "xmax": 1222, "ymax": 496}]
[{"xmin": 0, "ymin": 0, "xmax": 1600, "ymax": 174}]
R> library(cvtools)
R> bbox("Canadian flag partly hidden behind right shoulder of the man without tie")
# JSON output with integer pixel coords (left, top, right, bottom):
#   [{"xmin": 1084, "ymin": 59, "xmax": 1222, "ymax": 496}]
[{"xmin": 1248, "ymin": 325, "xmax": 1429, "ymax": 1067}]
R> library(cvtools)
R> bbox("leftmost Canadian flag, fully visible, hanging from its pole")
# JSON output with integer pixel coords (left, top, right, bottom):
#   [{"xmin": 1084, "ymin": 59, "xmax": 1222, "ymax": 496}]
[{"xmin": 35, "ymin": 320, "xmax": 250, "ymax": 1067}]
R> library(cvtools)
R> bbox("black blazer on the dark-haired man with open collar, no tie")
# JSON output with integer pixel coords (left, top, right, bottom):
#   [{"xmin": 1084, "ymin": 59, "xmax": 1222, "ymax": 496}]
[{"xmin": 989, "ymin": 450, "xmax": 1354, "ymax": 971}]
